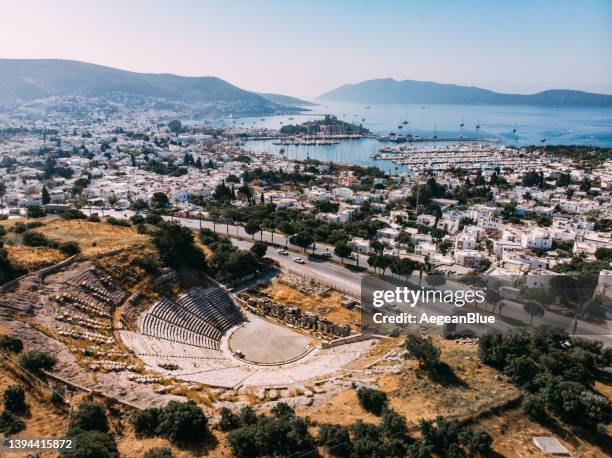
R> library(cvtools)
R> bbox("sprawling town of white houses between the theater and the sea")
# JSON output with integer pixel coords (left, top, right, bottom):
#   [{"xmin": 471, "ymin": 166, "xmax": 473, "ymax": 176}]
[{"xmin": 0, "ymin": 104, "xmax": 612, "ymax": 290}]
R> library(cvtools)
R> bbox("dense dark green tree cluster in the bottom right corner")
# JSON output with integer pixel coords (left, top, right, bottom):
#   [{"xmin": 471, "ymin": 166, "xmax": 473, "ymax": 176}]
[{"xmin": 479, "ymin": 332, "xmax": 612, "ymax": 429}]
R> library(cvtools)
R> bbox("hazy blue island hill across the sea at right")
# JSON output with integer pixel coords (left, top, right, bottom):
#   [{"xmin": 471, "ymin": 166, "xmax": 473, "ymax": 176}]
[{"xmin": 319, "ymin": 78, "xmax": 612, "ymax": 107}]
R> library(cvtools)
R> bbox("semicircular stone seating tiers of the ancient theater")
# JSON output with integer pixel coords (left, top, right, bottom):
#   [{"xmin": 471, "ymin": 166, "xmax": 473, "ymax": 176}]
[{"xmin": 120, "ymin": 288, "xmax": 373, "ymax": 388}]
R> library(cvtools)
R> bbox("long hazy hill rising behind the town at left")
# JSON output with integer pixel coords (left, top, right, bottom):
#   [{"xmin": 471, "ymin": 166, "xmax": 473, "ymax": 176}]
[{"xmin": 0, "ymin": 59, "xmax": 304, "ymax": 113}]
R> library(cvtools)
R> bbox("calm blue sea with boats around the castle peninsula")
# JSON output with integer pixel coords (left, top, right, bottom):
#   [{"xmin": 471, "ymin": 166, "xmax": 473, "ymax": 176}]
[{"xmin": 196, "ymin": 100, "xmax": 612, "ymax": 170}]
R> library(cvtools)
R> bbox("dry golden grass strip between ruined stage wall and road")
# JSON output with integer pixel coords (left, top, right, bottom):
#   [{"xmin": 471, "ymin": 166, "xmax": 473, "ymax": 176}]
[{"xmin": 262, "ymin": 279, "xmax": 361, "ymax": 329}]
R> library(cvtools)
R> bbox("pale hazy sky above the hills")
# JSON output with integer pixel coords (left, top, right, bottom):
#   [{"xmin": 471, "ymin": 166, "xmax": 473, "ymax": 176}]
[{"xmin": 0, "ymin": 0, "xmax": 612, "ymax": 96}]
